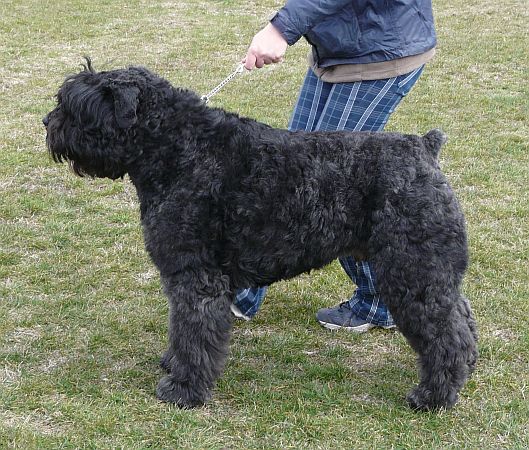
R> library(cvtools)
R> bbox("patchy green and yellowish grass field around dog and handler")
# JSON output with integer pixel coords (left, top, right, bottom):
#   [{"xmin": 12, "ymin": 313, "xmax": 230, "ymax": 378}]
[{"xmin": 0, "ymin": 0, "xmax": 529, "ymax": 449}]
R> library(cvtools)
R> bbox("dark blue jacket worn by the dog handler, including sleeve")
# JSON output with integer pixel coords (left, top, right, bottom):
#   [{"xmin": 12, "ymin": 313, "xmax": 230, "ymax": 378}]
[{"xmin": 271, "ymin": 0, "xmax": 436, "ymax": 67}]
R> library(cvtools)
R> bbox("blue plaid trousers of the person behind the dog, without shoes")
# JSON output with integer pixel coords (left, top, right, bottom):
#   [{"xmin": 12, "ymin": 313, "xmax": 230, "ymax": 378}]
[{"xmin": 234, "ymin": 66, "xmax": 424, "ymax": 326}]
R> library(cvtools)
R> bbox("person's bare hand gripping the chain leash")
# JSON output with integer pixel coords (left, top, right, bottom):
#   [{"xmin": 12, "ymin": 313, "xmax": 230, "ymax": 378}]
[{"xmin": 242, "ymin": 23, "xmax": 288, "ymax": 70}]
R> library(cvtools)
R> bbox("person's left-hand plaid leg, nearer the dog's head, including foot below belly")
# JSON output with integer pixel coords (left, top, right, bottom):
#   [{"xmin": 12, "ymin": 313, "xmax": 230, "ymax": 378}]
[{"xmin": 231, "ymin": 70, "xmax": 332, "ymax": 320}]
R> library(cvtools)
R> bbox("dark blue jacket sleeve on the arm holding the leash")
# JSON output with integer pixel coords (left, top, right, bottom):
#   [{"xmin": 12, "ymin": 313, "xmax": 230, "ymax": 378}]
[{"xmin": 270, "ymin": 0, "xmax": 352, "ymax": 45}]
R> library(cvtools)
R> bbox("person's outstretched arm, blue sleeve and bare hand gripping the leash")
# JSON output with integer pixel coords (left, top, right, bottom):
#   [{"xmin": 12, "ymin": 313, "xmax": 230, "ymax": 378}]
[{"xmin": 243, "ymin": 0, "xmax": 352, "ymax": 70}]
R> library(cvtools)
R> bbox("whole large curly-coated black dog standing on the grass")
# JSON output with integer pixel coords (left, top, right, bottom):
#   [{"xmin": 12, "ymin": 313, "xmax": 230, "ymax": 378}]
[{"xmin": 44, "ymin": 61, "xmax": 477, "ymax": 409}]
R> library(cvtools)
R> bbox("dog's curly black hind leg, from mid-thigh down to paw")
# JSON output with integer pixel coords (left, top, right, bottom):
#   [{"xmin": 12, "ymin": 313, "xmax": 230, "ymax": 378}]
[{"xmin": 373, "ymin": 236, "xmax": 477, "ymax": 410}]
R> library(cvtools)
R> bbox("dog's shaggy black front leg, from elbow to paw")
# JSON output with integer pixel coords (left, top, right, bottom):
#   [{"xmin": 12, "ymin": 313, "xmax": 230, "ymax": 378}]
[{"xmin": 156, "ymin": 272, "xmax": 232, "ymax": 408}]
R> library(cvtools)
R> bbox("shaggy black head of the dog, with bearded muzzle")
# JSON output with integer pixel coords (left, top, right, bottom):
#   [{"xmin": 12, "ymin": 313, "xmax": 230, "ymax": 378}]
[{"xmin": 43, "ymin": 58, "xmax": 171, "ymax": 179}]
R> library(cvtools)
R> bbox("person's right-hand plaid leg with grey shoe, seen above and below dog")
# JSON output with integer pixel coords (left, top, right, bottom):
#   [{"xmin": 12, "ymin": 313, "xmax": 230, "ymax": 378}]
[{"xmin": 316, "ymin": 67, "xmax": 422, "ymax": 332}]
